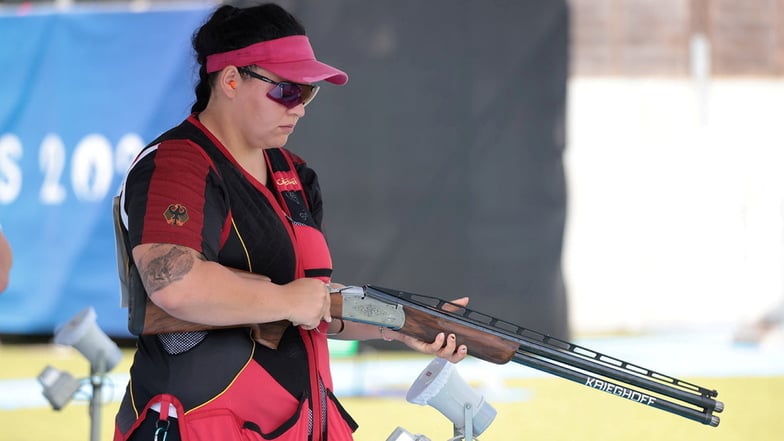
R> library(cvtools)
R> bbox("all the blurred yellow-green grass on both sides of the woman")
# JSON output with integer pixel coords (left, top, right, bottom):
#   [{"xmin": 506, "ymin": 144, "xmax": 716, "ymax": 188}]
[{"xmin": 0, "ymin": 345, "xmax": 784, "ymax": 441}]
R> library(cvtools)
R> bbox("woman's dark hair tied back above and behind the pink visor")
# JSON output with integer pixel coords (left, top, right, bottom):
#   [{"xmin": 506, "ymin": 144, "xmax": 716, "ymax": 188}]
[{"xmin": 191, "ymin": 3, "xmax": 305, "ymax": 112}]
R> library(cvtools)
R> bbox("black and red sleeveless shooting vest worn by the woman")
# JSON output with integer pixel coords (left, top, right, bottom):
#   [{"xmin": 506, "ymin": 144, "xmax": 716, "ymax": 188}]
[{"xmin": 115, "ymin": 116, "xmax": 357, "ymax": 441}]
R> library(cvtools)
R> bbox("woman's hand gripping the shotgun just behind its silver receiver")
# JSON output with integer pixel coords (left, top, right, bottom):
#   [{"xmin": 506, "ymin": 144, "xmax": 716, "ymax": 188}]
[{"xmin": 284, "ymin": 278, "xmax": 332, "ymax": 330}]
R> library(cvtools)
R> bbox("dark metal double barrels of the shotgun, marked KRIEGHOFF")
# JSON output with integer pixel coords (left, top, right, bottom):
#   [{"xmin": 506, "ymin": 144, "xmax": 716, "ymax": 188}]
[{"xmin": 364, "ymin": 285, "xmax": 724, "ymax": 427}]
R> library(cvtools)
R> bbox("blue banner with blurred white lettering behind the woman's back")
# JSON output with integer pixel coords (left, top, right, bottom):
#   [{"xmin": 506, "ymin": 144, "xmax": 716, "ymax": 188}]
[{"xmin": 0, "ymin": 5, "xmax": 209, "ymax": 337}]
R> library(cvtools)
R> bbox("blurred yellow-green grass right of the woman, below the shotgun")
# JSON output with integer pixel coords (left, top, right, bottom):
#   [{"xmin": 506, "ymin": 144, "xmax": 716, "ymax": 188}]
[{"xmin": 344, "ymin": 377, "xmax": 784, "ymax": 441}]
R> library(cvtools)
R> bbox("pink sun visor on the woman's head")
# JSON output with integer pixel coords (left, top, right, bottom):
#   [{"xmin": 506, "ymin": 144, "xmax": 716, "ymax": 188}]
[{"xmin": 207, "ymin": 35, "xmax": 348, "ymax": 85}]
